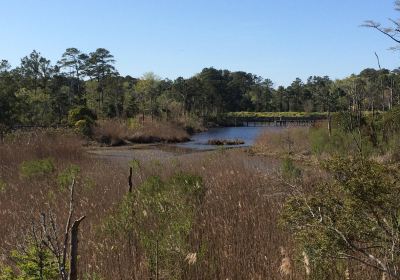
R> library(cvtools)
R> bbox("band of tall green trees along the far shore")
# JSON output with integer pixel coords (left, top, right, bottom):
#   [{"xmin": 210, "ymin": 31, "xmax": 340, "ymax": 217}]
[{"xmin": 0, "ymin": 48, "xmax": 400, "ymax": 125}]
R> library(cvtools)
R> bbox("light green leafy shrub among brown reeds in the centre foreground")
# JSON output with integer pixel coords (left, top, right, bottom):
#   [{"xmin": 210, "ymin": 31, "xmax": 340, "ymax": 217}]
[{"xmin": 105, "ymin": 173, "xmax": 205, "ymax": 279}]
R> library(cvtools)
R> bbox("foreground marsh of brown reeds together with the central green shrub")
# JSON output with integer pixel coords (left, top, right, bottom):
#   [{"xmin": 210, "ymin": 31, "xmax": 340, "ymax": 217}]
[{"xmin": 0, "ymin": 131, "xmax": 290, "ymax": 279}]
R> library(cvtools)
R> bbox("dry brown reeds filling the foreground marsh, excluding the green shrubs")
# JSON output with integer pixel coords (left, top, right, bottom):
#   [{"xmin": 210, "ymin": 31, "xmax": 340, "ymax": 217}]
[{"xmin": 0, "ymin": 131, "xmax": 382, "ymax": 279}]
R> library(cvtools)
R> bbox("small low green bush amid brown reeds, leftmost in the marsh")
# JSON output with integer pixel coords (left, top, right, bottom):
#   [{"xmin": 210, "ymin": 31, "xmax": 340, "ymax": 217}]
[{"xmin": 19, "ymin": 158, "xmax": 55, "ymax": 179}]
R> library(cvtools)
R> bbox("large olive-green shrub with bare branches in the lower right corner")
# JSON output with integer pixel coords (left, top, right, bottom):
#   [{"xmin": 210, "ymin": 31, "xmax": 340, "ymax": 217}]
[{"xmin": 282, "ymin": 158, "xmax": 400, "ymax": 279}]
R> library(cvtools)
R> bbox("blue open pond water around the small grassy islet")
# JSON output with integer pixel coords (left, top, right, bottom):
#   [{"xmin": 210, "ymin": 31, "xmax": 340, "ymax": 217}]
[{"xmin": 177, "ymin": 126, "xmax": 282, "ymax": 150}]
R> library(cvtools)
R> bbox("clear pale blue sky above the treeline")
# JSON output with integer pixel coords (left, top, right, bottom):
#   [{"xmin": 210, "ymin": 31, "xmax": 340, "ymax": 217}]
[{"xmin": 0, "ymin": 0, "xmax": 400, "ymax": 85}]
